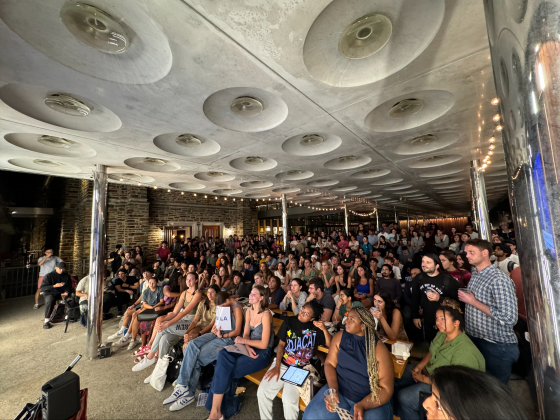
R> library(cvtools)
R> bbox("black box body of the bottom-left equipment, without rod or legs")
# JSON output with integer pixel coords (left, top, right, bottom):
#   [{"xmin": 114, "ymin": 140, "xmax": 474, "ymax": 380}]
[{"xmin": 41, "ymin": 371, "xmax": 80, "ymax": 420}]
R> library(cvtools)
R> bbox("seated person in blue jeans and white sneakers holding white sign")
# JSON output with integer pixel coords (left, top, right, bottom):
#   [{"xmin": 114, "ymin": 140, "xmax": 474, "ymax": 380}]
[{"xmin": 163, "ymin": 292, "xmax": 243, "ymax": 411}]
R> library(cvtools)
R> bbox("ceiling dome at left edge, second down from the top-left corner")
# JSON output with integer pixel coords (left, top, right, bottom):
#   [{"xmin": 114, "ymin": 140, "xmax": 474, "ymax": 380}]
[{"xmin": 0, "ymin": 83, "xmax": 122, "ymax": 133}]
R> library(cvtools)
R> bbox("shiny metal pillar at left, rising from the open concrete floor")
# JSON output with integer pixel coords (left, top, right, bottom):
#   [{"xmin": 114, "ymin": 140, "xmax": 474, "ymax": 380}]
[{"xmin": 86, "ymin": 165, "xmax": 107, "ymax": 360}]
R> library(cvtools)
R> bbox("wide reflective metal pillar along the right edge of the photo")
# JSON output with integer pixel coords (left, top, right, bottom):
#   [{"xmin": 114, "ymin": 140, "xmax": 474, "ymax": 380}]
[{"xmin": 484, "ymin": 0, "xmax": 560, "ymax": 420}]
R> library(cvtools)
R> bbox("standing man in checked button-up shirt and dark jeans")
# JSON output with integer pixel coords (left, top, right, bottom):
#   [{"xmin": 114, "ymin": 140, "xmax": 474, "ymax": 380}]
[{"xmin": 459, "ymin": 239, "xmax": 519, "ymax": 384}]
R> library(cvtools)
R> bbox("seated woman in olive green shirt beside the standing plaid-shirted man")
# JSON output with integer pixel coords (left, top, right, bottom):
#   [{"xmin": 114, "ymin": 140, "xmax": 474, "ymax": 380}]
[{"xmin": 393, "ymin": 298, "xmax": 486, "ymax": 420}]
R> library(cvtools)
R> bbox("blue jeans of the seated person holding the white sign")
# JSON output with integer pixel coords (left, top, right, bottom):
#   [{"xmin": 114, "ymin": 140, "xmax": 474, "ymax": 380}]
[{"xmin": 177, "ymin": 333, "xmax": 235, "ymax": 396}]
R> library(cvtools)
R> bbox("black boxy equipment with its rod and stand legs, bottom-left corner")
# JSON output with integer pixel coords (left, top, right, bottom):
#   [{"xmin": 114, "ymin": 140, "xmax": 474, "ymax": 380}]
[{"xmin": 14, "ymin": 354, "xmax": 82, "ymax": 420}]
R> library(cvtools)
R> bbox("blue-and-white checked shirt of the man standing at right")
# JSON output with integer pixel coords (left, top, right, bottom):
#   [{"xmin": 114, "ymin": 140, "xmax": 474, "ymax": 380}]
[{"xmin": 465, "ymin": 265, "xmax": 517, "ymax": 343}]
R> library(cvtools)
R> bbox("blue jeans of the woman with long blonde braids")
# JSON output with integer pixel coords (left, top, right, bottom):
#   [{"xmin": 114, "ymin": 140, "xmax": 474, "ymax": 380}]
[{"xmin": 303, "ymin": 384, "xmax": 393, "ymax": 420}]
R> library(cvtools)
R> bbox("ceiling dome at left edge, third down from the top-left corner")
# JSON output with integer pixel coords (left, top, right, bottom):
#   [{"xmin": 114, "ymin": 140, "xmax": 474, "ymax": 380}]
[{"xmin": 4, "ymin": 133, "xmax": 97, "ymax": 157}]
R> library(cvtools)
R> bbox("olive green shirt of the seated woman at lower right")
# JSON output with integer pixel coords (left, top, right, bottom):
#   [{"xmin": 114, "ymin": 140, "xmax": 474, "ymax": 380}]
[{"xmin": 426, "ymin": 332, "xmax": 486, "ymax": 375}]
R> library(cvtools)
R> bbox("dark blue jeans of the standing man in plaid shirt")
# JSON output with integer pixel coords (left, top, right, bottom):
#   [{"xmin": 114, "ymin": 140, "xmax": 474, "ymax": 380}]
[{"xmin": 469, "ymin": 335, "xmax": 519, "ymax": 385}]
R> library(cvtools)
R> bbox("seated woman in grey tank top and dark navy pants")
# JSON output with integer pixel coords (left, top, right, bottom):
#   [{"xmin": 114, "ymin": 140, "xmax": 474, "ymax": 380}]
[{"xmin": 206, "ymin": 286, "xmax": 274, "ymax": 419}]
